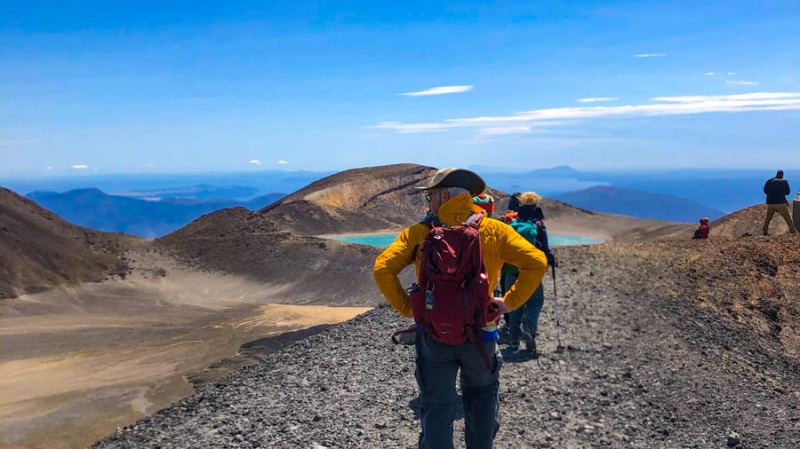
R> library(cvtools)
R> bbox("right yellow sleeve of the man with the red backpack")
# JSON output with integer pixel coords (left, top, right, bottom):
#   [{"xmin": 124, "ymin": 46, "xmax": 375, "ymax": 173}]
[{"xmin": 502, "ymin": 226, "xmax": 547, "ymax": 310}]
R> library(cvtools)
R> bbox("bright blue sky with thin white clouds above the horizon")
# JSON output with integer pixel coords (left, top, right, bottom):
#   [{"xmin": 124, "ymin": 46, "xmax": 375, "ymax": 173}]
[{"xmin": 0, "ymin": 0, "xmax": 800, "ymax": 177}]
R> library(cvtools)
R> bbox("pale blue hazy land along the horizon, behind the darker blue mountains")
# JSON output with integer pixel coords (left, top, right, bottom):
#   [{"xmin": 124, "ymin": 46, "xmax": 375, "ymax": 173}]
[{"xmin": 7, "ymin": 165, "xmax": 800, "ymax": 213}]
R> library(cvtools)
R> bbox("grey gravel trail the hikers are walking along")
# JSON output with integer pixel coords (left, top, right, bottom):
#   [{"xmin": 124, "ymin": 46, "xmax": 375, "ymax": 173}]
[{"xmin": 93, "ymin": 243, "xmax": 800, "ymax": 449}]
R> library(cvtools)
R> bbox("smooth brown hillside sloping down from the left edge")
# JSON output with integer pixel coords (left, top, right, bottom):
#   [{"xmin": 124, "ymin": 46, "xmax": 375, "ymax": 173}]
[{"xmin": 0, "ymin": 188, "xmax": 140, "ymax": 299}]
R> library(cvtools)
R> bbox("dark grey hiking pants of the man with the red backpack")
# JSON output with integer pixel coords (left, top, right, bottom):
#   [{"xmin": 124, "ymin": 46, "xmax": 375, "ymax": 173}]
[{"xmin": 415, "ymin": 333, "xmax": 503, "ymax": 449}]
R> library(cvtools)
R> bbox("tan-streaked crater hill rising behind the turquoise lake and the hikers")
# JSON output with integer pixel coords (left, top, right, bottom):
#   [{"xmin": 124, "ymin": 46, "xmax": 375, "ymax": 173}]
[{"xmin": 260, "ymin": 164, "xmax": 691, "ymax": 241}]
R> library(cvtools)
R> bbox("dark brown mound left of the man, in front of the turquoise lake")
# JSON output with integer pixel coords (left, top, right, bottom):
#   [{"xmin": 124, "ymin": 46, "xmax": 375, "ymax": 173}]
[{"xmin": 156, "ymin": 207, "xmax": 392, "ymax": 305}]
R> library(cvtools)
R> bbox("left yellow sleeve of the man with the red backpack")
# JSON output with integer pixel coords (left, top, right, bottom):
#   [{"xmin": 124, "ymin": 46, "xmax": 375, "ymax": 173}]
[{"xmin": 372, "ymin": 228, "xmax": 414, "ymax": 317}]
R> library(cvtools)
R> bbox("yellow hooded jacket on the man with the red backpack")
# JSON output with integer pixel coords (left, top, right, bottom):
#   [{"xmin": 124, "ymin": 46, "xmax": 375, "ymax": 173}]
[{"xmin": 373, "ymin": 193, "xmax": 547, "ymax": 317}]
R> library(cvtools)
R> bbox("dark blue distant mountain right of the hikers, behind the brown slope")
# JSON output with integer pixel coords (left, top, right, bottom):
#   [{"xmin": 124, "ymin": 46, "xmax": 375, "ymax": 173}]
[{"xmin": 553, "ymin": 186, "xmax": 725, "ymax": 223}]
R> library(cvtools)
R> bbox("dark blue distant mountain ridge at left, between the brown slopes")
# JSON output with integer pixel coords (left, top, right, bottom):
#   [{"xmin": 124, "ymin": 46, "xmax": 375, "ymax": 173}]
[{"xmin": 27, "ymin": 189, "xmax": 285, "ymax": 238}]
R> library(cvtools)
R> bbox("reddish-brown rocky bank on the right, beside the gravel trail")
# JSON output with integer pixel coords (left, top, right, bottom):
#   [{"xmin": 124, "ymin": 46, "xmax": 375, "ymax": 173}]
[{"xmin": 616, "ymin": 234, "xmax": 800, "ymax": 357}]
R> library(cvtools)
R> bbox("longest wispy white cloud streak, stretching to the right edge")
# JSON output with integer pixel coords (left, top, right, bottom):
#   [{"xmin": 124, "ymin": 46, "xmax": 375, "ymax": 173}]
[{"xmin": 375, "ymin": 92, "xmax": 800, "ymax": 135}]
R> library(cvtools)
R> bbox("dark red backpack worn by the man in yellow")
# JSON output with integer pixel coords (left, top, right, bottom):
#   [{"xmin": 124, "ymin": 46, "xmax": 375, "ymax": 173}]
[{"xmin": 401, "ymin": 214, "xmax": 498, "ymax": 349}]
